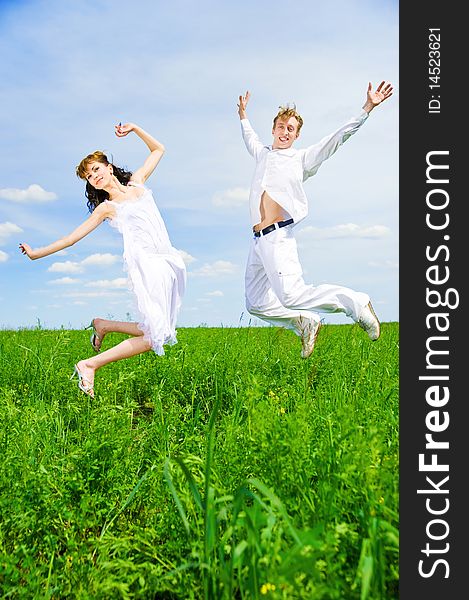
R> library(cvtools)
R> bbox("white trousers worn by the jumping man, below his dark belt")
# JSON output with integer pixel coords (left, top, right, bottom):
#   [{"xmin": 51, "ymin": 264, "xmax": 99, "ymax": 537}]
[{"xmin": 245, "ymin": 225, "xmax": 370, "ymax": 335}]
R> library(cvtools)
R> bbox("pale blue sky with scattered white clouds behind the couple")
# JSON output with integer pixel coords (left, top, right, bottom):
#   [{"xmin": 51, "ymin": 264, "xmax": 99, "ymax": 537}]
[{"xmin": 0, "ymin": 0, "xmax": 399, "ymax": 328}]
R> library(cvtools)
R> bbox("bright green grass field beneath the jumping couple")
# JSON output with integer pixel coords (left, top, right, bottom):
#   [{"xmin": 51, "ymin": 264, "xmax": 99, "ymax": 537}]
[{"xmin": 0, "ymin": 323, "xmax": 399, "ymax": 600}]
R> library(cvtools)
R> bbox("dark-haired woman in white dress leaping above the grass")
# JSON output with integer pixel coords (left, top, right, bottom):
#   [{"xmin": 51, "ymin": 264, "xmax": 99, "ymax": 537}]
[{"xmin": 20, "ymin": 123, "xmax": 186, "ymax": 398}]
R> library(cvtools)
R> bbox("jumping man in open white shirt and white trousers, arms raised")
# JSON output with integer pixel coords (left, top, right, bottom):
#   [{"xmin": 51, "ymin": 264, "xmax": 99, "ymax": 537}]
[{"xmin": 238, "ymin": 81, "xmax": 393, "ymax": 358}]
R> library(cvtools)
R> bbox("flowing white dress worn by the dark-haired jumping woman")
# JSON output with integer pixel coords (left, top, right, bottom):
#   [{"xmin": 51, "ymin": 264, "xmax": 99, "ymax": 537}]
[{"xmin": 106, "ymin": 181, "xmax": 186, "ymax": 355}]
